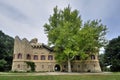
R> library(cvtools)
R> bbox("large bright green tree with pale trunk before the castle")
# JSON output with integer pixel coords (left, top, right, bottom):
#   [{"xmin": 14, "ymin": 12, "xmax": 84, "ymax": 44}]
[{"xmin": 44, "ymin": 6, "xmax": 106, "ymax": 72}]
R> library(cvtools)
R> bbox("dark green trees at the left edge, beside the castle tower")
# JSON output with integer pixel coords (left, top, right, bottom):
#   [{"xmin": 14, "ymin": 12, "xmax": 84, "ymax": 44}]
[{"xmin": 0, "ymin": 31, "xmax": 14, "ymax": 71}]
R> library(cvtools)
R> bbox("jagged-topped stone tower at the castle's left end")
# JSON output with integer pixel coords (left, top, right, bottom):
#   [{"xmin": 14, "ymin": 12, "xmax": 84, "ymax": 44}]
[{"xmin": 12, "ymin": 36, "xmax": 32, "ymax": 71}]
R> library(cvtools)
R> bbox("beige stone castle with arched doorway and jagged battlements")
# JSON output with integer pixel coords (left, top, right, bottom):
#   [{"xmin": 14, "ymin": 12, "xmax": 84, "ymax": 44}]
[{"xmin": 12, "ymin": 36, "xmax": 101, "ymax": 72}]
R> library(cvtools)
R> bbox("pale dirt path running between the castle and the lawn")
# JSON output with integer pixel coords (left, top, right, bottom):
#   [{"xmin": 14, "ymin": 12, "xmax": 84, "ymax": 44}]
[{"xmin": 0, "ymin": 72, "xmax": 113, "ymax": 76}]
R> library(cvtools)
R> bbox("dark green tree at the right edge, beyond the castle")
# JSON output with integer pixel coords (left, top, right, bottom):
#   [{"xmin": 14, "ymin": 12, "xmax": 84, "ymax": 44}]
[{"xmin": 104, "ymin": 36, "xmax": 120, "ymax": 72}]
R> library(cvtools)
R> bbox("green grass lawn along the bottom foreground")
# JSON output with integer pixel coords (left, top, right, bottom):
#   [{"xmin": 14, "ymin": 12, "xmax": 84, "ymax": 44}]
[{"xmin": 0, "ymin": 73, "xmax": 120, "ymax": 80}]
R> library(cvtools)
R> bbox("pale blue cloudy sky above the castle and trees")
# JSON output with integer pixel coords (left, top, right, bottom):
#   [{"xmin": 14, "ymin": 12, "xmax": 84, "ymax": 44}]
[{"xmin": 0, "ymin": 0, "xmax": 120, "ymax": 44}]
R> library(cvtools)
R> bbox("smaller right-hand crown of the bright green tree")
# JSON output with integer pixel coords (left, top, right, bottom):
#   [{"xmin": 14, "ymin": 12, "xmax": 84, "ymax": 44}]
[{"xmin": 80, "ymin": 20, "xmax": 107, "ymax": 53}]
